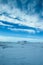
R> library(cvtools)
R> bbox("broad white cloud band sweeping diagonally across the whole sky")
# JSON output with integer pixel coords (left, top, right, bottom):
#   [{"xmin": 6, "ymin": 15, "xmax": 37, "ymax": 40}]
[{"xmin": 0, "ymin": 4, "xmax": 43, "ymax": 30}]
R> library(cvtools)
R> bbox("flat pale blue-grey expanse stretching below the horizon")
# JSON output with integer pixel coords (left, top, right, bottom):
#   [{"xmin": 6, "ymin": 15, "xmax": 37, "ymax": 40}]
[{"xmin": 0, "ymin": 42, "xmax": 43, "ymax": 65}]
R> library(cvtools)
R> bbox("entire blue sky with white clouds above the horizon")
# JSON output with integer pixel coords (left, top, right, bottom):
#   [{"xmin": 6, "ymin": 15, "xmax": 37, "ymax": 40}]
[{"xmin": 0, "ymin": 0, "xmax": 43, "ymax": 41}]
